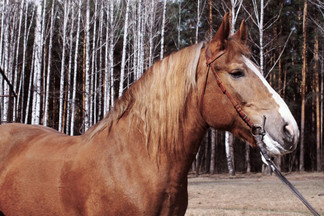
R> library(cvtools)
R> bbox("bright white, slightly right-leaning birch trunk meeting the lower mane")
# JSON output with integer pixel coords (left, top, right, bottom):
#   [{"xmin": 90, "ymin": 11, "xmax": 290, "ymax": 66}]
[{"xmin": 118, "ymin": 0, "xmax": 130, "ymax": 97}]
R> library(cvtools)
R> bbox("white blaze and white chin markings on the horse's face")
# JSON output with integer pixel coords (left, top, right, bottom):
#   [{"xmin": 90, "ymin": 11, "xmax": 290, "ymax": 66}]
[{"xmin": 243, "ymin": 56, "xmax": 299, "ymax": 154}]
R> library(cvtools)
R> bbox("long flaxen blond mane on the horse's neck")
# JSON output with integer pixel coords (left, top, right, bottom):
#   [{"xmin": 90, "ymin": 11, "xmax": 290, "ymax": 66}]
[{"xmin": 85, "ymin": 43, "xmax": 203, "ymax": 152}]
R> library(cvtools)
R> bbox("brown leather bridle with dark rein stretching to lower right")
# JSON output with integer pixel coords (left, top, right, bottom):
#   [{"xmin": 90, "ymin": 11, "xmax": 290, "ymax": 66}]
[{"xmin": 204, "ymin": 48, "xmax": 320, "ymax": 216}]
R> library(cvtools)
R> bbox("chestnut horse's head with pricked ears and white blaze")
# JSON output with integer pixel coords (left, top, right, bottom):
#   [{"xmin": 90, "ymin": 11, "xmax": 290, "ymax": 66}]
[{"xmin": 200, "ymin": 14, "xmax": 299, "ymax": 155}]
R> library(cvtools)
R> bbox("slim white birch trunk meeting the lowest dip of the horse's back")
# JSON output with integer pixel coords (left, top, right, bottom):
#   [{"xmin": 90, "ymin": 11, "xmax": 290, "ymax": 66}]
[{"xmin": 70, "ymin": 0, "xmax": 82, "ymax": 136}]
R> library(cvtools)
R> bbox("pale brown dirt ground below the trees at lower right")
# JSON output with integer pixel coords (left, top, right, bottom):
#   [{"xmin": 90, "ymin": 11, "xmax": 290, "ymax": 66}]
[{"xmin": 186, "ymin": 172, "xmax": 324, "ymax": 216}]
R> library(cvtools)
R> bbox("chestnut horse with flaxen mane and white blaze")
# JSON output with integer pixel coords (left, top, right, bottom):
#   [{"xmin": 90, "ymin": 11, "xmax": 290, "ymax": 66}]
[{"xmin": 0, "ymin": 14, "xmax": 299, "ymax": 216}]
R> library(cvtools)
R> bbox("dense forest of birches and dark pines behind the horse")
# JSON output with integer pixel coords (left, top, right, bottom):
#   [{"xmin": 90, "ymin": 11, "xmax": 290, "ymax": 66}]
[{"xmin": 0, "ymin": 0, "xmax": 324, "ymax": 172}]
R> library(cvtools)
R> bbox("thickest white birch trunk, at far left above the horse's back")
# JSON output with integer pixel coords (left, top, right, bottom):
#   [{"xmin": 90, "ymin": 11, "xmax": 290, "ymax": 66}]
[{"xmin": 31, "ymin": 0, "xmax": 43, "ymax": 124}]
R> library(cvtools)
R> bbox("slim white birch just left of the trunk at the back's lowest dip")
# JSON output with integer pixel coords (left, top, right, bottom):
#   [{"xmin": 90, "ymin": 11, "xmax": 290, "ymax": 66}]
[{"xmin": 58, "ymin": 0, "xmax": 70, "ymax": 132}]
